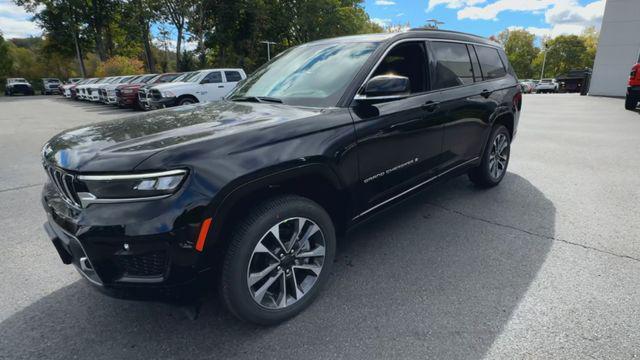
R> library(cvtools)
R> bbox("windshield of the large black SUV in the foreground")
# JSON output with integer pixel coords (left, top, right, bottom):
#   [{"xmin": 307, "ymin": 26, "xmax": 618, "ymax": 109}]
[{"xmin": 229, "ymin": 43, "xmax": 378, "ymax": 107}]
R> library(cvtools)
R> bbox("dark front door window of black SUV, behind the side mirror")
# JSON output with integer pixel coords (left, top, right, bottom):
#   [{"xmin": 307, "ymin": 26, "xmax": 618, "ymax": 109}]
[{"xmin": 371, "ymin": 42, "xmax": 427, "ymax": 94}]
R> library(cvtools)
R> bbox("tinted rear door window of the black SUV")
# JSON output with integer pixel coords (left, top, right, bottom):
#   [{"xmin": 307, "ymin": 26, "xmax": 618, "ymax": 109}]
[{"xmin": 431, "ymin": 42, "xmax": 473, "ymax": 89}]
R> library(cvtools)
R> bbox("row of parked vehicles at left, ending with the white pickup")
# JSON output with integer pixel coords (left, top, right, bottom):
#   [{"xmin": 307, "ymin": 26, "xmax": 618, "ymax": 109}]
[{"xmin": 60, "ymin": 69, "xmax": 247, "ymax": 110}]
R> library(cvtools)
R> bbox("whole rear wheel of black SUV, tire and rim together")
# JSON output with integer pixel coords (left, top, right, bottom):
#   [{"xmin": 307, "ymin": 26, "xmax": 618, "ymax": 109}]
[{"xmin": 469, "ymin": 125, "xmax": 511, "ymax": 187}]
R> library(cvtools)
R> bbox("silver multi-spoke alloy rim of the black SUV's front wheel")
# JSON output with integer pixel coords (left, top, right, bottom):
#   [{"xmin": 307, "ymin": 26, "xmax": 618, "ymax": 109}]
[{"xmin": 247, "ymin": 217, "xmax": 325, "ymax": 309}]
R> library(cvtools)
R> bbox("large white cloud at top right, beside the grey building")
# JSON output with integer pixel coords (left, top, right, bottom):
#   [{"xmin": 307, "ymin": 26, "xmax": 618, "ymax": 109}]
[{"xmin": 458, "ymin": 0, "xmax": 605, "ymax": 37}]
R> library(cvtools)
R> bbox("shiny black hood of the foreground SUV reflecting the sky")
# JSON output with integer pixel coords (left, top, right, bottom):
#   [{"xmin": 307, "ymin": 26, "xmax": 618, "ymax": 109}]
[{"xmin": 42, "ymin": 101, "xmax": 323, "ymax": 172}]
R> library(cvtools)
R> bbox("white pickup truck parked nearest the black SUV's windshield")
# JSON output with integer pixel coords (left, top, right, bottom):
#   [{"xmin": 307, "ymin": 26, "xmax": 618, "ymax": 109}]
[{"xmin": 147, "ymin": 69, "xmax": 247, "ymax": 108}]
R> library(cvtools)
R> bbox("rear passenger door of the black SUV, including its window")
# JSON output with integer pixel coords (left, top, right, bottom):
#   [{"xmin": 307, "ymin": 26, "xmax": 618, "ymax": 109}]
[{"xmin": 430, "ymin": 41, "xmax": 496, "ymax": 169}]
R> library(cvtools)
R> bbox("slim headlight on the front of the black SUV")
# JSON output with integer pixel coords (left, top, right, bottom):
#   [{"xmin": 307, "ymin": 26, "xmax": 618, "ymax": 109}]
[{"xmin": 78, "ymin": 170, "xmax": 187, "ymax": 207}]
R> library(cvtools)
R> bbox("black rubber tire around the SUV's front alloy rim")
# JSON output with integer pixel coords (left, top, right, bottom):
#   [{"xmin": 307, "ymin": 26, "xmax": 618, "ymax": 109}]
[{"xmin": 220, "ymin": 195, "xmax": 336, "ymax": 325}]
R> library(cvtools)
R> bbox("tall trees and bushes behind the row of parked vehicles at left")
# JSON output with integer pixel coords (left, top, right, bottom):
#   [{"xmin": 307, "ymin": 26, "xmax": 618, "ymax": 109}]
[{"xmin": 0, "ymin": 0, "xmax": 382, "ymax": 79}]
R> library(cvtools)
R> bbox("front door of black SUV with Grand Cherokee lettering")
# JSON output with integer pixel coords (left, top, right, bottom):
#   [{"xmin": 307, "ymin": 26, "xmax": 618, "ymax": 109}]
[{"xmin": 351, "ymin": 41, "xmax": 443, "ymax": 211}]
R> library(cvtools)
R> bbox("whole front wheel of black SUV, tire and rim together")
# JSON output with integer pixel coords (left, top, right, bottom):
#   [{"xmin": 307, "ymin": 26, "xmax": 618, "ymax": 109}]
[{"xmin": 220, "ymin": 195, "xmax": 336, "ymax": 325}]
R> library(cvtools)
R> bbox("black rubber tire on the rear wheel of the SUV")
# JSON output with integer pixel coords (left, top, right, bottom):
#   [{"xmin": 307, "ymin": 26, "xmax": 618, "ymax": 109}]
[{"xmin": 469, "ymin": 124, "xmax": 511, "ymax": 188}]
